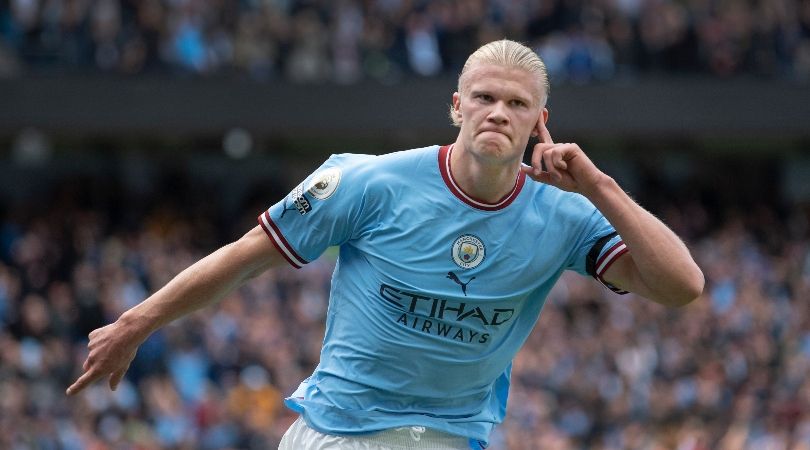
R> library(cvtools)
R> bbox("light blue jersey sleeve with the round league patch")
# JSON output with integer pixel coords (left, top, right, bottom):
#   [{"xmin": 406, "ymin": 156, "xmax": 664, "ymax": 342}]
[{"xmin": 258, "ymin": 155, "xmax": 370, "ymax": 268}]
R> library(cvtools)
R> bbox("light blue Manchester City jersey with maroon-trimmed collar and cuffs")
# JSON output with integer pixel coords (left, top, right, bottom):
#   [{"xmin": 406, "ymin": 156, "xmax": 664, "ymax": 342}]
[{"xmin": 259, "ymin": 146, "xmax": 627, "ymax": 448}]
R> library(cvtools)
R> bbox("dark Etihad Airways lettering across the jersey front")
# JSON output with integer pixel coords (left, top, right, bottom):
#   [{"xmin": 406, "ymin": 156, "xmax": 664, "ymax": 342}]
[{"xmin": 380, "ymin": 283, "xmax": 515, "ymax": 344}]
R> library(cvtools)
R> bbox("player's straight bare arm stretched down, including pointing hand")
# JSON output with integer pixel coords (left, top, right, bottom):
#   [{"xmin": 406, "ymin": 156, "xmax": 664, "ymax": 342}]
[{"xmin": 67, "ymin": 226, "xmax": 281, "ymax": 395}]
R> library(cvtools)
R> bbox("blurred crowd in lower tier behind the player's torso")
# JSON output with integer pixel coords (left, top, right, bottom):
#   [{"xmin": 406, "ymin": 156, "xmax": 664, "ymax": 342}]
[{"xmin": 0, "ymin": 163, "xmax": 810, "ymax": 450}]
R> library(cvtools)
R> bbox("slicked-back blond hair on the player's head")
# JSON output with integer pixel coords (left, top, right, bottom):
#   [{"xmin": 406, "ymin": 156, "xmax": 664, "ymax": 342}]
[{"xmin": 450, "ymin": 39, "xmax": 551, "ymax": 127}]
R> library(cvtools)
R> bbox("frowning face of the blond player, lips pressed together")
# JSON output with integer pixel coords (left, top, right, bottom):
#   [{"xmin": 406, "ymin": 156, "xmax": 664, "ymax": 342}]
[{"xmin": 453, "ymin": 64, "xmax": 547, "ymax": 163}]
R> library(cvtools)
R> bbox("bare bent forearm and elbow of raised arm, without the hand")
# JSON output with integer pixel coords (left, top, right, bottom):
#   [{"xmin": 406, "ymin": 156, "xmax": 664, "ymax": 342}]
[{"xmin": 586, "ymin": 176, "xmax": 703, "ymax": 305}]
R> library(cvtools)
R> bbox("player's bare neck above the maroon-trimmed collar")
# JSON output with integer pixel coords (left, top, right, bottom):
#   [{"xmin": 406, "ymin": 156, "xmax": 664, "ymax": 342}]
[{"xmin": 450, "ymin": 142, "xmax": 520, "ymax": 203}]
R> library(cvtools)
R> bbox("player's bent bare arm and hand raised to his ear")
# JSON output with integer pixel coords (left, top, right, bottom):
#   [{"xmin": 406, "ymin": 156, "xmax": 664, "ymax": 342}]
[{"xmin": 522, "ymin": 114, "xmax": 704, "ymax": 306}]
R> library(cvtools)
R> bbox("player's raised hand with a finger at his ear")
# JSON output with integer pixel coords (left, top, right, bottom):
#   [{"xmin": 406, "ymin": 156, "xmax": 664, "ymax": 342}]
[{"xmin": 521, "ymin": 120, "xmax": 605, "ymax": 196}]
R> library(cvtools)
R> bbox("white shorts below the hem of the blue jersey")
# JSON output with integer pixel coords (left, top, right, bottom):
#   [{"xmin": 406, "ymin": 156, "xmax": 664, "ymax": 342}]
[{"xmin": 278, "ymin": 417, "xmax": 470, "ymax": 450}]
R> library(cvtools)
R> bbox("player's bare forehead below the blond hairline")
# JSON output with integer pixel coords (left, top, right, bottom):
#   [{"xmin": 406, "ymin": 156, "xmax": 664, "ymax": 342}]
[{"xmin": 459, "ymin": 64, "xmax": 542, "ymax": 100}]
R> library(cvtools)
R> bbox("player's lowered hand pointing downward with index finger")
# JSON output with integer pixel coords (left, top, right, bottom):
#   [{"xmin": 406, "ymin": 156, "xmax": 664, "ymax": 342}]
[{"xmin": 65, "ymin": 321, "xmax": 142, "ymax": 395}]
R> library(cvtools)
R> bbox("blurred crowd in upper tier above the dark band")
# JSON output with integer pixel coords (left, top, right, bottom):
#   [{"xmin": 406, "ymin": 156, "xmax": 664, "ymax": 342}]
[{"xmin": 0, "ymin": 0, "xmax": 810, "ymax": 83}]
